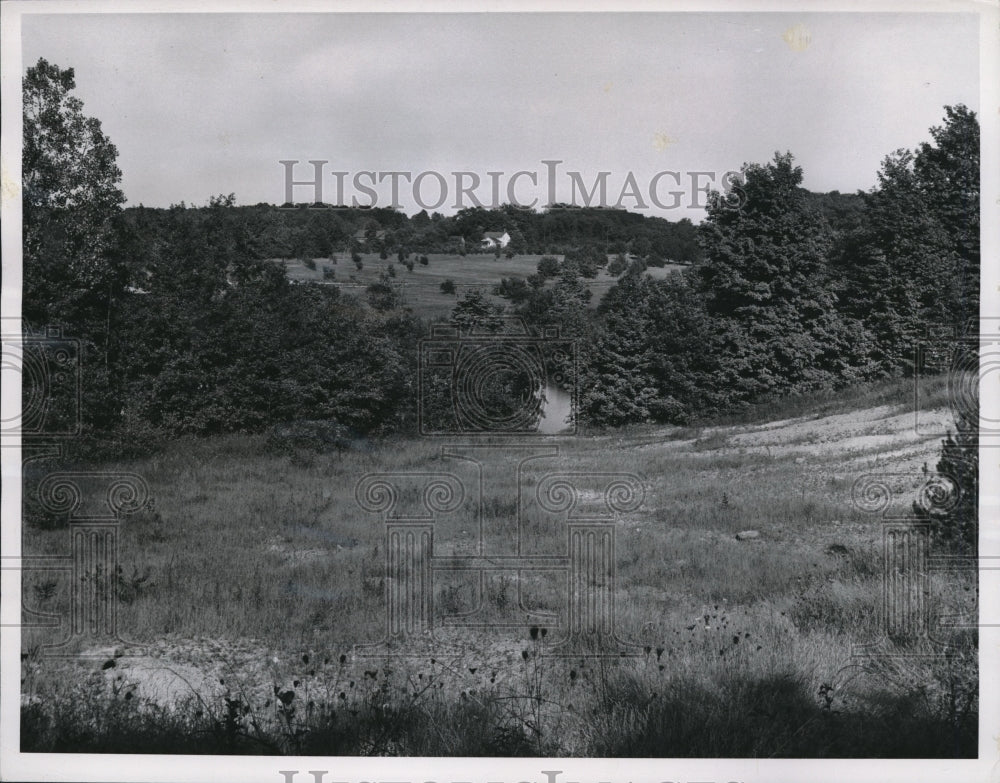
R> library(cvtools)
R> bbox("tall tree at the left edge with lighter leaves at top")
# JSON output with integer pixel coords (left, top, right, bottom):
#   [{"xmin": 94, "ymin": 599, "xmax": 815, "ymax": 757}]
[{"xmin": 21, "ymin": 59, "xmax": 129, "ymax": 426}]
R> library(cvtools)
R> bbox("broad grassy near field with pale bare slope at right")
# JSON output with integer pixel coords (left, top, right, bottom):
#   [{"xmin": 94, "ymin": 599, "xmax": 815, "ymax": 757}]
[{"xmin": 22, "ymin": 376, "xmax": 978, "ymax": 757}]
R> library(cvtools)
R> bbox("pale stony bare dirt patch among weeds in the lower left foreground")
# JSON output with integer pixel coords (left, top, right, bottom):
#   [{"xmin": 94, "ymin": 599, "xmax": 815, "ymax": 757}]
[{"xmin": 78, "ymin": 626, "xmax": 588, "ymax": 721}]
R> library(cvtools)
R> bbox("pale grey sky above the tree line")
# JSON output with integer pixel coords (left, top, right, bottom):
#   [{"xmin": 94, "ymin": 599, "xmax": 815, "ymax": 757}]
[{"xmin": 22, "ymin": 13, "xmax": 979, "ymax": 221}]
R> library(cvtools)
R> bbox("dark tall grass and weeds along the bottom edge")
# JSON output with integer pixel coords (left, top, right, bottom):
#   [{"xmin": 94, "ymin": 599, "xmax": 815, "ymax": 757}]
[{"xmin": 21, "ymin": 648, "xmax": 978, "ymax": 758}]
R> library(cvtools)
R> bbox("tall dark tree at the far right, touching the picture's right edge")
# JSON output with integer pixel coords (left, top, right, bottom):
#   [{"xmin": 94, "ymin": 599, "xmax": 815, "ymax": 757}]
[{"xmin": 837, "ymin": 106, "xmax": 979, "ymax": 374}]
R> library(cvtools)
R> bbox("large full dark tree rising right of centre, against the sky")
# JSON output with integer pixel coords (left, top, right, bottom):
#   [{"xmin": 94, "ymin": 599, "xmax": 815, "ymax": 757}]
[{"xmin": 696, "ymin": 153, "xmax": 857, "ymax": 400}]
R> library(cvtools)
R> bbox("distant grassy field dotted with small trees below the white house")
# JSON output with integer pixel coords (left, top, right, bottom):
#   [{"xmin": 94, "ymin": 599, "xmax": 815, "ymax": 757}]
[{"xmin": 282, "ymin": 253, "xmax": 683, "ymax": 318}]
